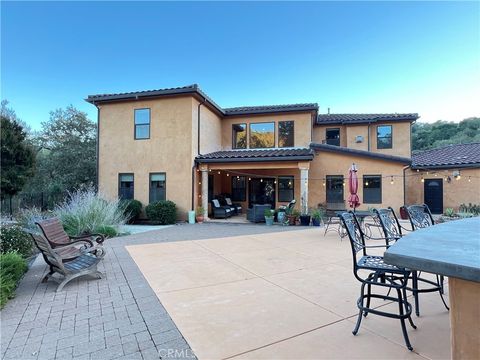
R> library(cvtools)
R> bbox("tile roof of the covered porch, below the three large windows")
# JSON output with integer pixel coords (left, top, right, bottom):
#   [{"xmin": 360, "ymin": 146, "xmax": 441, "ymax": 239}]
[{"xmin": 195, "ymin": 148, "xmax": 313, "ymax": 163}]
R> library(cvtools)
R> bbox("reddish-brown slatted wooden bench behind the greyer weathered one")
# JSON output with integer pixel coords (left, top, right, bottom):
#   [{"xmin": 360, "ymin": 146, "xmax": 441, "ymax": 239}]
[{"xmin": 35, "ymin": 218, "xmax": 105, "ymax": 261}]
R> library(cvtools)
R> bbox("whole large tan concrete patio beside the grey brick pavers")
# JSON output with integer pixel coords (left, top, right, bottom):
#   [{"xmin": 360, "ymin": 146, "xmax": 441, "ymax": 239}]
[{"xmin": 128, "ymin": 228, "xmax": 450, "ymax": 360}]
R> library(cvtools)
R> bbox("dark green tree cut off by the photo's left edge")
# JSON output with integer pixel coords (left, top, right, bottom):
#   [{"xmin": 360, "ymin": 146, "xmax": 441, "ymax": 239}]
[{"xmin": 1, "ymin": 111, "xmax": 35, "ymax": 204}]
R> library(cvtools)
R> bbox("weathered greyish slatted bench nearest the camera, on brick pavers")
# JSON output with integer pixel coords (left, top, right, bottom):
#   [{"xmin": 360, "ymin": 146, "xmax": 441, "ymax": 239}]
[{"xmin": 30, "ymin": 233, "xmax": 105, "ymax": 292}]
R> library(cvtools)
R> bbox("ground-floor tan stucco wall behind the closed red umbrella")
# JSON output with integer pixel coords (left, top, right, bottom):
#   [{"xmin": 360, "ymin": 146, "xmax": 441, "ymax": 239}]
[{"xmin": 308, "ymin": 152, "xmax": 404, "ymax": 210}]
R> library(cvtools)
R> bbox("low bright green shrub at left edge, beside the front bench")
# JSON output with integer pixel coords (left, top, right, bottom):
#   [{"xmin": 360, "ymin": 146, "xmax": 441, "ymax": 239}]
[{"xmin": 0, "ymin": 252, "xmax": 28, "ymax": 308}]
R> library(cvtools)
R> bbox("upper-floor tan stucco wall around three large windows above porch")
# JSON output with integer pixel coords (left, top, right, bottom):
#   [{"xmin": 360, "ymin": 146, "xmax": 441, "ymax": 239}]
[{"xmin": 222, "ymin": 113, "xmax": 312, "ymax": 150}]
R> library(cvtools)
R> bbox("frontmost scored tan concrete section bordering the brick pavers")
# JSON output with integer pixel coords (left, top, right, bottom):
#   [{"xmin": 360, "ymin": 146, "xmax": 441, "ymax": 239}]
[{"xmin": 156, "ymin": 278, "xmax": 341, "ymax": 359}]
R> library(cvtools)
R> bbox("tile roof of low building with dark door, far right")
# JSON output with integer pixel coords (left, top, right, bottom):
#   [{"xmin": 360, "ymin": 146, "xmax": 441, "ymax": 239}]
[{"xmin": 412, "ymin": 143, "xmax": 480, "ymax": 168}]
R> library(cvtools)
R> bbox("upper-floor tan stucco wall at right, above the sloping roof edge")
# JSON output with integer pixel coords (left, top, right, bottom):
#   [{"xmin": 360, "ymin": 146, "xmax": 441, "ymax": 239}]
[{"xmin": 313, "ymin": 122, "xmax": 411, "ymax": 157}]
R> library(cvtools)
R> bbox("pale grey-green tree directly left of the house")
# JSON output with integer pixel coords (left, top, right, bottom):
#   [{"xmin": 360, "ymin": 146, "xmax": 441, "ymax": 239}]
[{"xmin": 22, "ymin": 106, "xmax": 96, "ymax": 205}]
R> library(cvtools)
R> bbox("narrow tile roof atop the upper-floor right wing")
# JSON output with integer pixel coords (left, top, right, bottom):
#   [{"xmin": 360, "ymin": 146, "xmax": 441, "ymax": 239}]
[{"xmin": 316, "ymin": 113, "xmax": 419, "ymax": 125}]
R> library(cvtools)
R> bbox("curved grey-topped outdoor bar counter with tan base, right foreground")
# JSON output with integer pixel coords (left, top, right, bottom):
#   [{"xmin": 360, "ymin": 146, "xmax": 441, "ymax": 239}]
[{"xmin": 384, "ymin": 217, "xmax": 480, "ymax": 360}]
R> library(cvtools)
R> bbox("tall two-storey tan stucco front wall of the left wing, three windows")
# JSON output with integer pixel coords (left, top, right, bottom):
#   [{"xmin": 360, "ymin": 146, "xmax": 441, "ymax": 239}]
[{"xmin": 99, "ymin": 97, "xmax": 196, "ymax": 219}]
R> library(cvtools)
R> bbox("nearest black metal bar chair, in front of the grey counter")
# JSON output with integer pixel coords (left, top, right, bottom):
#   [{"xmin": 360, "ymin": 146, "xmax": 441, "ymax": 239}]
[{"xmin": 340, "ymin": 212, "xmax": 416, "ymax": 350}]
